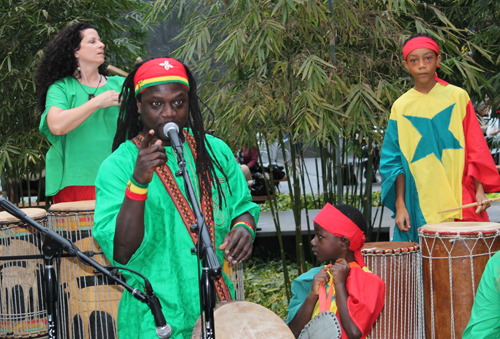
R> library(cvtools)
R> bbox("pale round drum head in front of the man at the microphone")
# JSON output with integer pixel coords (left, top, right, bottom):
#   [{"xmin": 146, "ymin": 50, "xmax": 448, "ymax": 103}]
[{"xmin": 191, "ymin": 301, "xmax": 295, "ymax": 339}]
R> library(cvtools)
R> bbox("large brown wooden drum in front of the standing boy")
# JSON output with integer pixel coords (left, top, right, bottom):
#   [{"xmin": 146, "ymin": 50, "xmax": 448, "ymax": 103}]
[{"xmin": 418, "ymin": 222, "xmax": 500, "ymax": 339}]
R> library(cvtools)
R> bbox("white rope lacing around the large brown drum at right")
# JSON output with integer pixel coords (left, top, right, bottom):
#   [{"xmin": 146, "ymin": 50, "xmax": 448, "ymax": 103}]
[{"xmin": 420, "ymin": 230, "xmax": 500, "ymax": 339}]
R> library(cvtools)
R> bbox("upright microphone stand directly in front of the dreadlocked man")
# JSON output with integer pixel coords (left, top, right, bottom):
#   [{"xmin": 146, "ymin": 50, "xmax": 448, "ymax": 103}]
[{"xmin": 172, "ymin": 144, "xmax": 222, "ymax": 339}]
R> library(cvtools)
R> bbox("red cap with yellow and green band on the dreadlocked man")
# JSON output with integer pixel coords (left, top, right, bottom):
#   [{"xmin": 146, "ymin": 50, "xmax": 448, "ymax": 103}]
[{"xmin": 134, "ymin": 58, "xmax": 189, "ymax": 96}]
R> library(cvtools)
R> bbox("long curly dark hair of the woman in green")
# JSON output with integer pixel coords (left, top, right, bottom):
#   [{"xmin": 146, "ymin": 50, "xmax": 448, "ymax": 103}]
[{"xmin": 36, "ymin": 22, "xmax": 108, "ymax": 112}]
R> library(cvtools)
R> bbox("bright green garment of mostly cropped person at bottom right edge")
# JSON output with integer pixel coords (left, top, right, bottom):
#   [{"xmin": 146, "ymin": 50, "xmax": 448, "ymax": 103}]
[{"xmin": 462, "ymin": 252, "xmax": 500, "ymax": 339}]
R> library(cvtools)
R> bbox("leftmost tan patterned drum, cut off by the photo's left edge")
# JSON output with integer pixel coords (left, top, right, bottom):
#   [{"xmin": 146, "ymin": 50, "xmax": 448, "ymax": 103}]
[{"xmin": 0, "ymin": 208, "xmax": 47, "ymax": 338}]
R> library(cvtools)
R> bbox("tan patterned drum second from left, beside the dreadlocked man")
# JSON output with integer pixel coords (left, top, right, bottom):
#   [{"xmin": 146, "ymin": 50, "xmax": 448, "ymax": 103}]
[{"xmin": 47, "ymin": 200, "xmax": 123, "ymax": 339}]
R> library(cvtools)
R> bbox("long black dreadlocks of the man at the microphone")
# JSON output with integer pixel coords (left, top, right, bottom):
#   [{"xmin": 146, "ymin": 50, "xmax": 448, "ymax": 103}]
[{"xmin": 112, "ymin": 58, "xmax": 231, "ymax": 209}]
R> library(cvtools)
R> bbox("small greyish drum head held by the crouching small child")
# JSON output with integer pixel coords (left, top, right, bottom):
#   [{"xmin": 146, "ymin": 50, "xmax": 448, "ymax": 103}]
[{"xmin": 299, "ymin": 311, "xmax": 342, "ymax": 339}]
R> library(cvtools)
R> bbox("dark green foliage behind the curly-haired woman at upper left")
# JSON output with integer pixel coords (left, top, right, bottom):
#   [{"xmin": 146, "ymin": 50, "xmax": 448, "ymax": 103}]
[{"xmin": 0, "ymin": 0, "xmax": 144, "ymax": 201}]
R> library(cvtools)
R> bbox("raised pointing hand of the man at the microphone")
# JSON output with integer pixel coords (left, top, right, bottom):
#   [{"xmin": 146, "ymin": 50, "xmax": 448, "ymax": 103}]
[{"xmin": 133, "ymin": 130, "xmax": 167, "ymax": 185}]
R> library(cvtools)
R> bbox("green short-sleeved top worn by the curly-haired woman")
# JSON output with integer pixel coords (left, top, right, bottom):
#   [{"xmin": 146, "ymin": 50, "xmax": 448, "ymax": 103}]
[{"xmin": 40, "ymin": 76, "xmax": 125, "ymax": 196}]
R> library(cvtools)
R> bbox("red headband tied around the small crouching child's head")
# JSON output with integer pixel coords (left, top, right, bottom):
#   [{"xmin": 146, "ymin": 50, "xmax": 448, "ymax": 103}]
[{"xmin": 314, "ymin": 203, "xmax": 366, "ymax": 267}]
